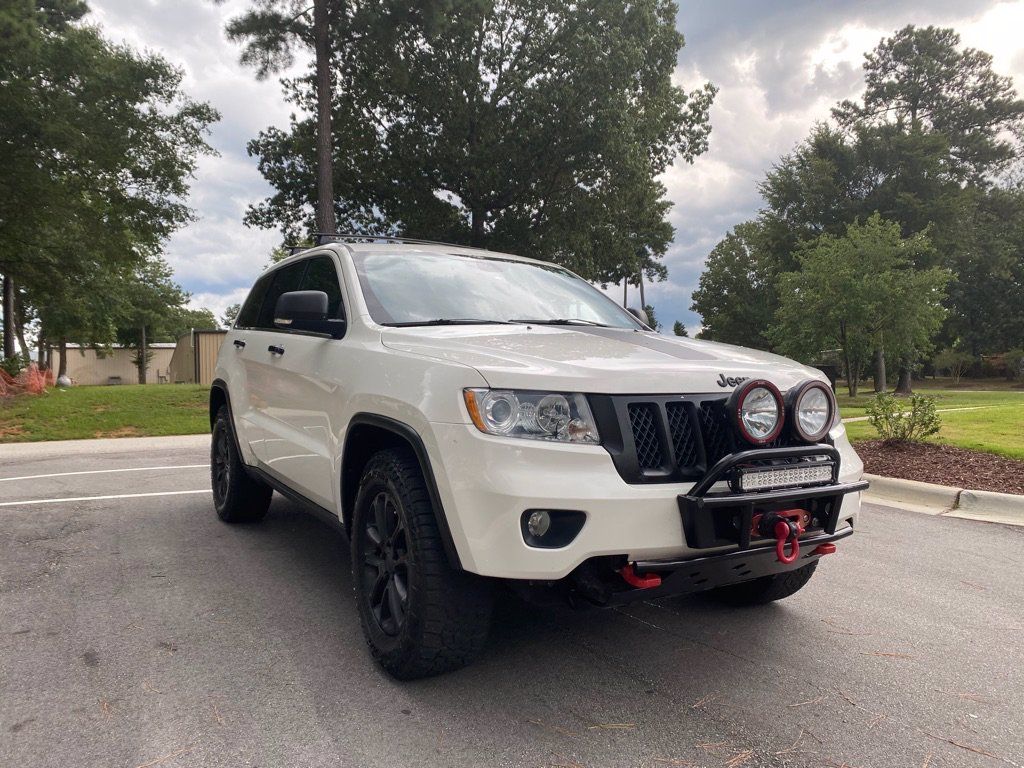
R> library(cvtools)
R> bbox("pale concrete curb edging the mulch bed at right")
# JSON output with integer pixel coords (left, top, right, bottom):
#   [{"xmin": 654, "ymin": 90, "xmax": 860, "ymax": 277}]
[{"xmin": 863, "ymin": 474, "xmax": 1024, "ymax": 525}]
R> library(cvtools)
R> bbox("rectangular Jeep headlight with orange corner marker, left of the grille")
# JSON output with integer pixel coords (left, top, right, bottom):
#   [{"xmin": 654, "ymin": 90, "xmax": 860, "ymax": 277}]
[{"xmin": 463, "ymin": 389, "xmax": 601, "ymax": 444}]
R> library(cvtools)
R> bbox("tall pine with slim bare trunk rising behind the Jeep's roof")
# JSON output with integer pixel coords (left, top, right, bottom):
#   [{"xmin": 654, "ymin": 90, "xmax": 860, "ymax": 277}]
[{"xmin": 216, "ymin": 0, "xmax": 342, "ymax": 233}]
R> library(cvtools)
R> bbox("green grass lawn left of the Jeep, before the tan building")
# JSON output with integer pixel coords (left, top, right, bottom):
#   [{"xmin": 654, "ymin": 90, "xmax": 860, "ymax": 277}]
[{"xmin": 0, "ymin": 384, "xmax": 210, "ymax": 442}]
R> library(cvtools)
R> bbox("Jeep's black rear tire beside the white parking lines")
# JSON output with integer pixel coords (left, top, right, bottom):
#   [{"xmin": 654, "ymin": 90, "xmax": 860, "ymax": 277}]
[{"xmin": 210, "ymin": 406, "xmax": 273, "ymax": 523}]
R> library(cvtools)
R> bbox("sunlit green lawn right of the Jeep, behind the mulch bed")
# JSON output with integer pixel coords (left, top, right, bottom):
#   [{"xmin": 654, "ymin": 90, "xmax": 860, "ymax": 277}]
[{"xmin": 838, "ymin": 383, "xmax": 1024, "ymax": 459}]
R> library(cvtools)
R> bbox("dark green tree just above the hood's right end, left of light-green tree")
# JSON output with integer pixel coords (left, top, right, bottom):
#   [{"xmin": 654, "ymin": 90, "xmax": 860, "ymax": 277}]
[{"xmin": 692, "ymin": 221, "xmax": 778, "ymax": 349}]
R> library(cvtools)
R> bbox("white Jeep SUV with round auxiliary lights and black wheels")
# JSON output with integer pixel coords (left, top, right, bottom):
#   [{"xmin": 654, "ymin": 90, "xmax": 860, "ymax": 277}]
[{"xmin": 210, "ymin": 238, "xmax": 866, "ymax": 678}]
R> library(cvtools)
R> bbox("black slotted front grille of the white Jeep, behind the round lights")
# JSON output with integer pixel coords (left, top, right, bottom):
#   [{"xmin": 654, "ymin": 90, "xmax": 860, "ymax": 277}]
[{"xmin": 588, "ymin": 393, "xmax": 829, "ymax": 484}]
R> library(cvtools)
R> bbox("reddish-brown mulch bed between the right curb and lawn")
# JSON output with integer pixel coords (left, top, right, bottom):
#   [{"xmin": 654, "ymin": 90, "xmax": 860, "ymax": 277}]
[{"xmin": 854, "ymin": 440, "xmax": 1024, "ymax": 494}]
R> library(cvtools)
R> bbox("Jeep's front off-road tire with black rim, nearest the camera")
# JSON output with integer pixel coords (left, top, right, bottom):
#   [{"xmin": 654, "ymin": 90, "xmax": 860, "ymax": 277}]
[{"xmin": 351, "ymin": 449, "xmax": 494, "ymax": 680}]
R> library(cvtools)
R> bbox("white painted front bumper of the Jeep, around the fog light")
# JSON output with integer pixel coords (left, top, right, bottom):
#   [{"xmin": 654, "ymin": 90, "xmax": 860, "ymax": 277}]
[{"xmin": 426, "ymin": 423, "xmax": 862, "ymax": 581}]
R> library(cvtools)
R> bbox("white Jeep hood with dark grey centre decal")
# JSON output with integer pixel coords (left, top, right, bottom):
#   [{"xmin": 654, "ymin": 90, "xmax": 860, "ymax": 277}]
[{"xmin": 381, "ymin": 325, "xmax": 824, "ymax": 394}]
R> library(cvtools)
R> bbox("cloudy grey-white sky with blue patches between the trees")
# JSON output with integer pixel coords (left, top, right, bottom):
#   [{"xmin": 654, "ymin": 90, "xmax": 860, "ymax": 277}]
[{"xmin": 90, "ymin": 0, "xmax": 1024, "ymax": 328}]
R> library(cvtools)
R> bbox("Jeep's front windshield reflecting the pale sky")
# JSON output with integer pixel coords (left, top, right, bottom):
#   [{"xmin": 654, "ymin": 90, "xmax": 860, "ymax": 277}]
[{"xmin": 353, "ymin": 251, "xmax": 642, "ymax": 330}]
